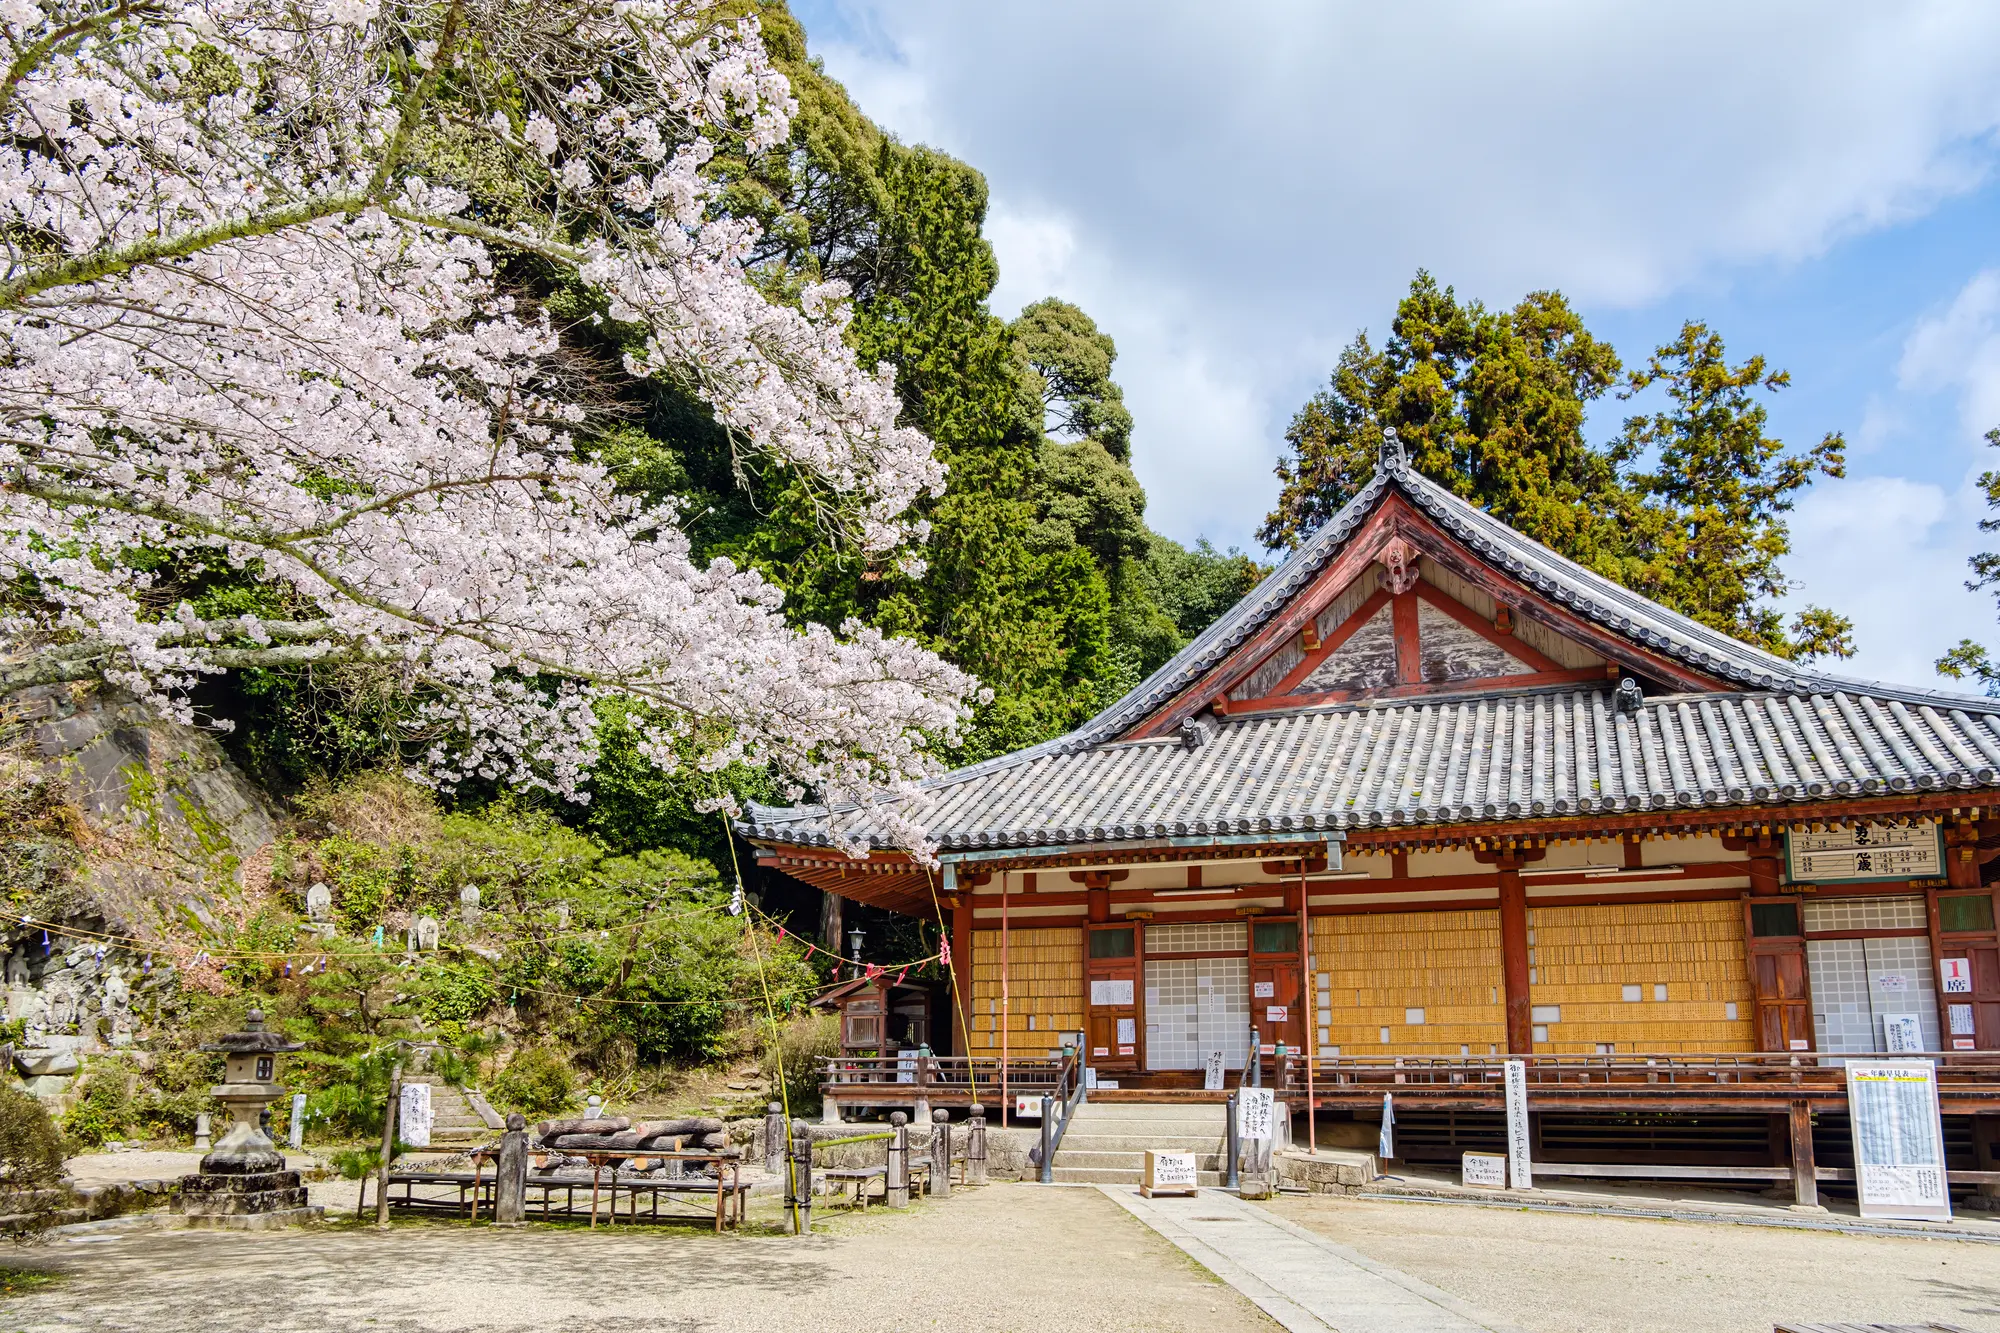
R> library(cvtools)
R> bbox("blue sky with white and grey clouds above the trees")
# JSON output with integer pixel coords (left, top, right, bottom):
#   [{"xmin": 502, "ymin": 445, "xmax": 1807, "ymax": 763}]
[{"xmin": 794, "ymin": 0, "xmax": 2000, "ymax": 685}]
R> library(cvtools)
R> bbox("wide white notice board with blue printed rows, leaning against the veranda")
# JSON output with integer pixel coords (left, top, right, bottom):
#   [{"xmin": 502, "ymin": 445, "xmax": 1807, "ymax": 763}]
[{"xmin": 1848, "ymin": 1059, "xmax": 1952, "ymax": 1221}]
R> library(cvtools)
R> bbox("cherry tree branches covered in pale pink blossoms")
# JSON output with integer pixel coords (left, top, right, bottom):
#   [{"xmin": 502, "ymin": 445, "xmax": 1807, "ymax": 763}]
[{"xmin": 0, "ymin": 0, "xmax": 974, "ymax": 845}]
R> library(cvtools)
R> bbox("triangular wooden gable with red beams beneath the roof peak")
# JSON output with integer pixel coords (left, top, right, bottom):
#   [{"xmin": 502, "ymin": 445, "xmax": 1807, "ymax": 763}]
[{"xmin": 1126, "ymin": 494, "xmax": 1728, "ymax": 737}]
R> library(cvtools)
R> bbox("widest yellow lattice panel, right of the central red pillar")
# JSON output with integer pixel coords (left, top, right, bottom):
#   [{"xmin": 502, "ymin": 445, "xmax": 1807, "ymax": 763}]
[{"xmin": 1528, "ymin": 903, "xmax": 1756, "ymax": 1055}]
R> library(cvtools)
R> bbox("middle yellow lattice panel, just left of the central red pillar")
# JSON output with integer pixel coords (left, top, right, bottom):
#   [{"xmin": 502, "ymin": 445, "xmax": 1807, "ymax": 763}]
[{"xmin": 1312, "ymin": 911, "xmax": 1506, "ymax": 1055}]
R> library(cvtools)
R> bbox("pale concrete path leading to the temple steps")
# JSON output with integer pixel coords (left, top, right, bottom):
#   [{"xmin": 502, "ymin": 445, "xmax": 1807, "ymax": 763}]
[{"xmin": 1100, "ymin": 1185, "xmax": 1518, "ymax": 1333}]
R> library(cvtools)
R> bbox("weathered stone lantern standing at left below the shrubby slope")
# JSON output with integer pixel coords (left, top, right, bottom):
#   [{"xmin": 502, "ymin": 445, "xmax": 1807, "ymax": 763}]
[{"xmin": 180, "ymin": 1009, "xmax": 320, "ymax": 1229}]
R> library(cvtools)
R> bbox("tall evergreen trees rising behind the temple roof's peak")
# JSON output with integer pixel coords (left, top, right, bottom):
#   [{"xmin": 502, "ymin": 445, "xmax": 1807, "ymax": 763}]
[{"xmin": 1258, "ymin": 272, "xmax": 1854, "ymax": 658}]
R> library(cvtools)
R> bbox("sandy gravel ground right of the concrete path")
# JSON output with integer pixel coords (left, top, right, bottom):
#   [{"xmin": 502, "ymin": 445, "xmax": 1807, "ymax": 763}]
[{"xmin": 1270, "ymin": 1197, "xmax": 2000, "ymax": 1333}]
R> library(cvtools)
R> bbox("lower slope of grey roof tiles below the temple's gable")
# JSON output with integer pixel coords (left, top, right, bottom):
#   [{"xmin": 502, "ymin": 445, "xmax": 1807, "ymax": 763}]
[{"xmin": 744, "ymin": 691, "xmax": 2000, "ymax": 851}]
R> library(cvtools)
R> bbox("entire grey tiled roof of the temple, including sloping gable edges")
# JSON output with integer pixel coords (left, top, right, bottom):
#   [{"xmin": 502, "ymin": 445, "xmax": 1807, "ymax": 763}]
[{"xmin": 738, "ymin": 448, "xmax": 2000, "ymax": 851}]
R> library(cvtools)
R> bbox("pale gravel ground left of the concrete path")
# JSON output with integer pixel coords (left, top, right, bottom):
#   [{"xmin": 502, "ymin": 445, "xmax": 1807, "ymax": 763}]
[{"xmin": 0, "ymin": 1185, "xmax": 1276, "ymax": 1333}]
